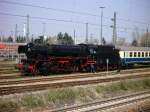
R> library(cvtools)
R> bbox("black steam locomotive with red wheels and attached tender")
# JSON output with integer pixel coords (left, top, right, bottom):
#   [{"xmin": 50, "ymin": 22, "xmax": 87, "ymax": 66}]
[{"xmin": 17, "ymin": 43, "xmax": 120, "ymax": 75}]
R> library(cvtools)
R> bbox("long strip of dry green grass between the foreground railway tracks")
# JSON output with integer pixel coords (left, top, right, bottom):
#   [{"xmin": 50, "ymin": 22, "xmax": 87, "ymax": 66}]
[{"xmin": 0, "ymin": 79, "xmax": 150, "ymax": 112}]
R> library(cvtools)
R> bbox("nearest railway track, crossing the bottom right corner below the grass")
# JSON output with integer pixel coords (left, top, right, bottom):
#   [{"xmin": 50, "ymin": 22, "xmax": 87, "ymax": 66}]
[{"xmin": 47, "ymin": 91, "xmax": 150, "ymax": 112}]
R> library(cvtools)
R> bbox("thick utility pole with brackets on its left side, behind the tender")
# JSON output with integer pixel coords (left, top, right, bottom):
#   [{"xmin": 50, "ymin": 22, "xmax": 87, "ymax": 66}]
[{"xmin": 111, "ymin": 12, "xmax": 117, "ymax": 45}]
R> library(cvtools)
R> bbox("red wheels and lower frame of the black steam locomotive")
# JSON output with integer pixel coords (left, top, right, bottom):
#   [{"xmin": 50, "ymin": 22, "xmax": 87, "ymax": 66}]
[{"xmin": 16, "ymin": 57, "xmax": 96, "ymax": 75}]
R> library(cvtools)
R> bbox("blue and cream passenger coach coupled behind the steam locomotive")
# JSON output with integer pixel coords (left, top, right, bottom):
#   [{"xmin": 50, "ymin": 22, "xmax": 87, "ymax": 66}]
[{"xmin": 119, "ymin": 47, "xmax": 150, "ymax": 66}]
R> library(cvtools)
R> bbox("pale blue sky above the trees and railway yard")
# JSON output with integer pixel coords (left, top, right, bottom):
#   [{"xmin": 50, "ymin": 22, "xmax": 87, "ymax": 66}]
[{"xmin": 0, "ymin": 0, "xmax": 150, "ymax": 43}]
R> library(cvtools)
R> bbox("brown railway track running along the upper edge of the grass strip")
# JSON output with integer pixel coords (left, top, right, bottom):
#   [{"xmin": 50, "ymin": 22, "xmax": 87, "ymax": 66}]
[{"xmin": 0, "ymin": 72, "xmax": 150, "ymax": 96}]
